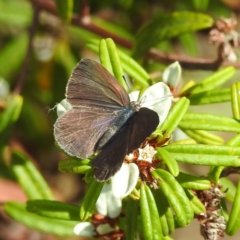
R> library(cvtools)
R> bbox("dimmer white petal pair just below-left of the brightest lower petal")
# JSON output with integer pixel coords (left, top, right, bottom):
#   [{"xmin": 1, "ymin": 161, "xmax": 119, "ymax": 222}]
[{"xmin": 96, "ymin": 184, "xmax": 122, "ymax": 218}]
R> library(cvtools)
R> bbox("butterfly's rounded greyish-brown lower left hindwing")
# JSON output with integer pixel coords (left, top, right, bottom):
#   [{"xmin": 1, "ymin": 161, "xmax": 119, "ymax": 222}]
[{"xmin": 54, "ymin": 108, "xmax": 116, "ymax": 158}]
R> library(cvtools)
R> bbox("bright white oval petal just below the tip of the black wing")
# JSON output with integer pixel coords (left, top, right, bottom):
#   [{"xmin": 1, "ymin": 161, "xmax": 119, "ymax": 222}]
[{"xmin": 111, "ymin": 163, "xmax": 139, "ymax": 199}]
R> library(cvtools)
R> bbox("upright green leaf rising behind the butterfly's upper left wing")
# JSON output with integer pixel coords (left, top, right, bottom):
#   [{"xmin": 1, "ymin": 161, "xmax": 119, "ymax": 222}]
[{"xmin": 99, "ymin": 38, "xmax": 128, "ymax": 90}]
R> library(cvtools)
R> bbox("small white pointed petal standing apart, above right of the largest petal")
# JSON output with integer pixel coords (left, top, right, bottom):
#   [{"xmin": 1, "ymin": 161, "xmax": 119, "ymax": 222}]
[{"xmin": 162, "ymin": 62, "xmax": 182, "ymax": 88}]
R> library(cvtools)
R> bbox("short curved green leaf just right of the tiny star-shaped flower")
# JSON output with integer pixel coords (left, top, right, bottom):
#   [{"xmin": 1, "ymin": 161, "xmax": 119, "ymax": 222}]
[{"xmin": 155, "ymin": 148, "xmax": 179, "ymax": 177}]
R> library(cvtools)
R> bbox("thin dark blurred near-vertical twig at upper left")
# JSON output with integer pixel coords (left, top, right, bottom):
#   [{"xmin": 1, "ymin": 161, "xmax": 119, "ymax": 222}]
[{"xmin": 13, "ymin": 4, "xmax": 40, "ymax": 95}]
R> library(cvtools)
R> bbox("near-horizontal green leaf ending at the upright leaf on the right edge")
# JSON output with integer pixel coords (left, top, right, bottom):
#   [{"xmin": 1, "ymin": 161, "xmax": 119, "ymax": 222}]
[{"xmin": 188, "ymin": 88, "xmax": 231, "ymax": 105}]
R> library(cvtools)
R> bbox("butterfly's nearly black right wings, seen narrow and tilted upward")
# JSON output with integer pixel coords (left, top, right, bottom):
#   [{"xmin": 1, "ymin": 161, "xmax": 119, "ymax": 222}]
[{"xmin": 92, "ymin": 108, "xmax": 159, "ymax": 181}]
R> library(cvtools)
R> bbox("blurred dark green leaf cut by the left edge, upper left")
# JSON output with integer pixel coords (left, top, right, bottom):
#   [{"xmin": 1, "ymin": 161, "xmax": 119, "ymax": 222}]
[{"xmin": 0, "ymin": 33, "xmax": 28, "ymax": 79}]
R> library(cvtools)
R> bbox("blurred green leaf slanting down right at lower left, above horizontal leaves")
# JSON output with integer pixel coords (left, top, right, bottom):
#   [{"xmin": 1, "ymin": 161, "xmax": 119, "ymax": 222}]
[{"xmin": 10, "ymin": 149, "xmax": 54, "ymax": 200}]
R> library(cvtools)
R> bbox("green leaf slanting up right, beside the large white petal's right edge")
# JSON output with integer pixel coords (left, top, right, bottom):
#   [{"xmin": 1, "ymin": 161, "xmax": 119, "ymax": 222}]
[{"xmin": 156, "ymin": 97, "xmax": 189, "ymax": 137}]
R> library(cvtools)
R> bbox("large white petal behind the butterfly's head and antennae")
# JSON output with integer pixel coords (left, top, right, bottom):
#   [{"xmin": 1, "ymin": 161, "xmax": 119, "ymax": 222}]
[{"xmin": 140, "ymin": 82, "xmax": 172, "ymax": 125}]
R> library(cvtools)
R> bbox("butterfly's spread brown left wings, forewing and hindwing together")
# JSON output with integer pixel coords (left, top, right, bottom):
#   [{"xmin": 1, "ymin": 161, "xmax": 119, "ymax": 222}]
[{"xmin": 54, "ymin": 59, "xmax": 129, "ymax": 158}]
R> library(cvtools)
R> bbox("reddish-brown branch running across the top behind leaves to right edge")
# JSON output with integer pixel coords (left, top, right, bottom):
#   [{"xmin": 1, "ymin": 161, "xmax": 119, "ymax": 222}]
[{"xmin": 31, "ymin": 0, "xmax": 240, "ymax": 70}]
